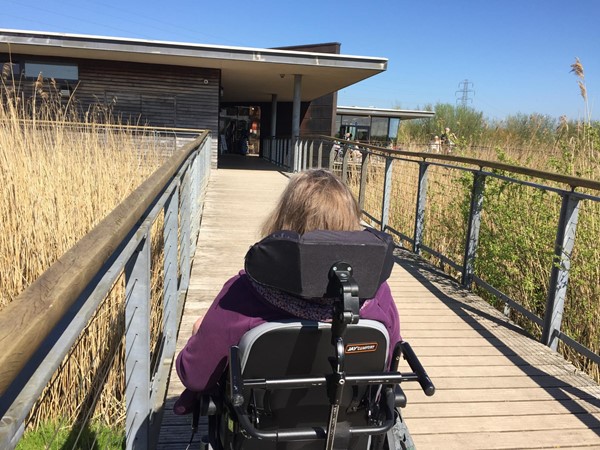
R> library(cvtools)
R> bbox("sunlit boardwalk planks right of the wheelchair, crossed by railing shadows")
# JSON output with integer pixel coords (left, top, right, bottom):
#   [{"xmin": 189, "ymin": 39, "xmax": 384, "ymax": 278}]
[{"xmin": 392, "ymin": 251, "xmax": 600, "ymax": 449}]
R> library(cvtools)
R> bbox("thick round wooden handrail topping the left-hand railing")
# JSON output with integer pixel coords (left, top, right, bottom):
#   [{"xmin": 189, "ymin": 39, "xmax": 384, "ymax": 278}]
[{"xmin": 0, "ymin": 131, "xmax": 208, "ymax": 395}]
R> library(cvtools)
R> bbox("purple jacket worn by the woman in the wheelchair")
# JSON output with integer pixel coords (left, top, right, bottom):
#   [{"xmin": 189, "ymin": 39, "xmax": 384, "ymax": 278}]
[{"xmin": 174, "ymin": 271, "xmax": 400, "ymax": 414}]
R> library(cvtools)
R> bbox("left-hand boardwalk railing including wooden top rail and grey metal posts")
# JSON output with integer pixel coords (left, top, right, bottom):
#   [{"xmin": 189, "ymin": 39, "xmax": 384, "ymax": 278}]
[{"xmin": 0, "ymin": 132, "xmax": 211, "ymax": 449}]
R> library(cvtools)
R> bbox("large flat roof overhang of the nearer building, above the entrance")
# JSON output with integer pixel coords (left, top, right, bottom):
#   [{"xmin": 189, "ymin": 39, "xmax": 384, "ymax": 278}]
[{"xmin": 0, "ymin": 29, "xmax": 387, "ymax": 102}]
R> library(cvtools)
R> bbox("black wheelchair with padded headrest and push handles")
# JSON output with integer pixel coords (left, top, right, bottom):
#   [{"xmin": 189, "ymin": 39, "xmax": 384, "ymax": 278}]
[{"xmin": 193, "ymin": 229, "xmax": 435, "ymax": 450}]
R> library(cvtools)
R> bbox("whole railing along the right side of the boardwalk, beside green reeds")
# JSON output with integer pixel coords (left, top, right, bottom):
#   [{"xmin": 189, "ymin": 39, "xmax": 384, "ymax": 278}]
[{"xmin": 263, "ymin": 136, "xmax": 600, "ymax": 370}]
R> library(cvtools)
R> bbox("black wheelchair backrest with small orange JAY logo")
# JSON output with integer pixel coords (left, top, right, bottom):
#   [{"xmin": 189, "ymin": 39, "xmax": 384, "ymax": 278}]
[{"xmin": 234, "ymin": 320, "xmax": 389, "ymax": 440}]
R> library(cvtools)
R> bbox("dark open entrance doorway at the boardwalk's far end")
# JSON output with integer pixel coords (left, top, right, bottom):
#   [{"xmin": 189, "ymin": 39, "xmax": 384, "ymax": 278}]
[{"xmin": 219, "ymin": 106, "xmax": 260, "ymax": 155}]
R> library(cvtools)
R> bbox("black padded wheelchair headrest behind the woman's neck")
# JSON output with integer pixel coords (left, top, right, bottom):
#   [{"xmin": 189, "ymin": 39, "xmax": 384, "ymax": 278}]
[{"xmin": 245, "ymin": 228, "xmax": 394, "ymax": 300}]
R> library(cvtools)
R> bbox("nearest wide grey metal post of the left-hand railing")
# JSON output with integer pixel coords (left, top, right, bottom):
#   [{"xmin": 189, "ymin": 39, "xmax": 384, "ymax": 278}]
[{"xmin": 125, "ymin": 235, "xmax": 150, "ymax": 450}]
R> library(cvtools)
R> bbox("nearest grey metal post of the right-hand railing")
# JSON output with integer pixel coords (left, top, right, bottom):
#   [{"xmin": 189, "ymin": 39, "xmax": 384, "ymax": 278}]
[{"xmin": 542, "ymin": 193, "xmax": 579, "ymax": 350}]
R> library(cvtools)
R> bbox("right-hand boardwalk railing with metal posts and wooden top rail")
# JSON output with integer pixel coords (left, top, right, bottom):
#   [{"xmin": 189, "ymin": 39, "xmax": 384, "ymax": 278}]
[{"xmin": 262, "ymin": 136, "xmax": 600, "ymax": 372}]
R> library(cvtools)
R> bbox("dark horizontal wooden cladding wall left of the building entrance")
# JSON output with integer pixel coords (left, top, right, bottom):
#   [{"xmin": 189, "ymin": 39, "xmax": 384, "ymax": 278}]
[{"xmin": 0, "ymin": 55, "xmax": 220, "ymax": 136}]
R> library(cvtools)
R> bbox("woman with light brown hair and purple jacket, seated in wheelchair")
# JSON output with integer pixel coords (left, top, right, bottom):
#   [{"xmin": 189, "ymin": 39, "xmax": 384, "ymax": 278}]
[{"xmin": 175, "ymin": 169, "xmax": 400, "ymax": 408}]
